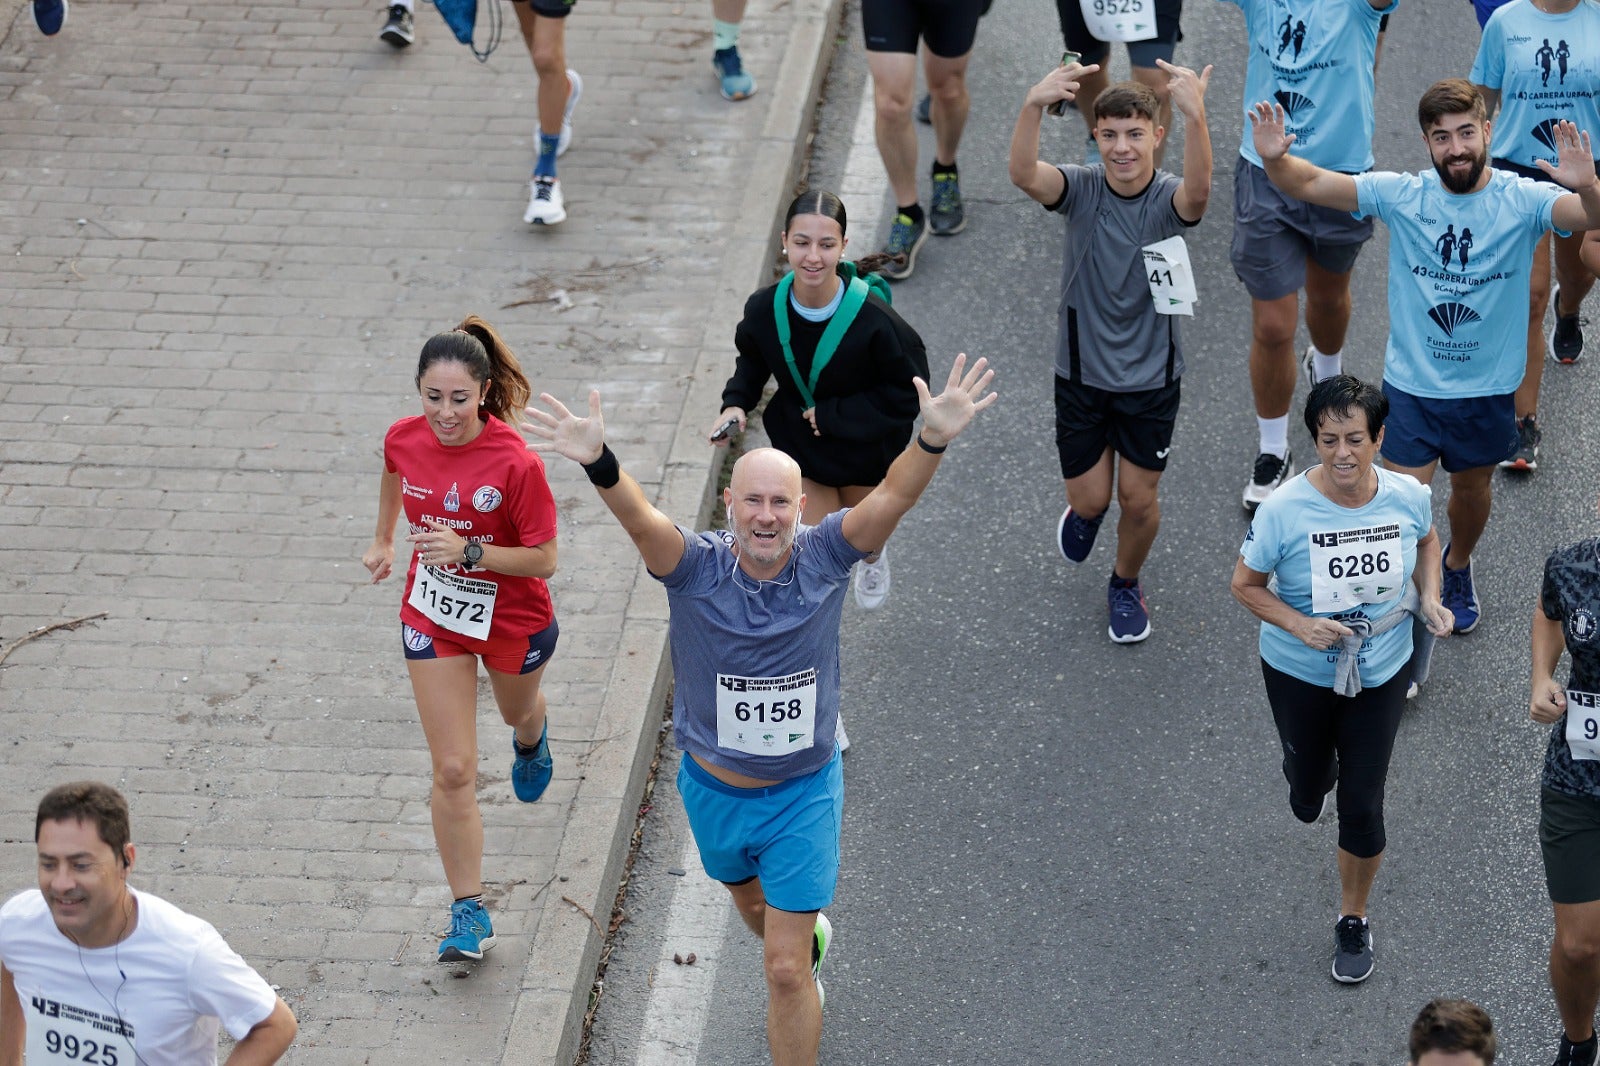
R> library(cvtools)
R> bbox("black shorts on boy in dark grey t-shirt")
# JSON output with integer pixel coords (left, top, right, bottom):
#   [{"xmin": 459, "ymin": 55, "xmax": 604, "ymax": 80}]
[{"xmin": 1056, "ymin": 375, "xmax": 1182, "ymax": 477}]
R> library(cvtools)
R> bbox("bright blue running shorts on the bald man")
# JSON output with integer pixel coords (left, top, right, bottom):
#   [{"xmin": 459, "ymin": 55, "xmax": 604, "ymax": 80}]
[{"xmin": 678, "ymin": 749, "xmax": 845, "ymax": 914}]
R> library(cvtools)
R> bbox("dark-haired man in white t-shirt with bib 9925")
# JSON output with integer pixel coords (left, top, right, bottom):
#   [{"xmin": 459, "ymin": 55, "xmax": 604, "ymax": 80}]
[{"xmin": 0, "ymin": 781, "xmax": 298, "ymax": 1066}]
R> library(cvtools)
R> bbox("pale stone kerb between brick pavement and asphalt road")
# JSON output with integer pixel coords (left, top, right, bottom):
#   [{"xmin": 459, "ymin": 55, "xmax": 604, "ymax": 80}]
[{"xmin": 499, "ymin": 0, "xmax": 843, "ymax": 1066}]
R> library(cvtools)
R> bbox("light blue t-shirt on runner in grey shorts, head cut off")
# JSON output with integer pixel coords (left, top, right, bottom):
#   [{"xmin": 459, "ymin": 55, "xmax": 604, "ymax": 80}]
[{"xmin": 1224, "ymin": 0, "xmax": 1398, "ymax": 174}]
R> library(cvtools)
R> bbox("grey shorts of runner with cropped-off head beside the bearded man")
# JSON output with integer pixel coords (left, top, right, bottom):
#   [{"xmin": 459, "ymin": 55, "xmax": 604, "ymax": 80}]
[{"xmin": 1229, "ymin": 157, "xmax": 1373, "ymax": 299}]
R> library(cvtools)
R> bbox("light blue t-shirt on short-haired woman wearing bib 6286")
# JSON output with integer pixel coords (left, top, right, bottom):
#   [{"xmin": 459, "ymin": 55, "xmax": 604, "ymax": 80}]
[{"xmin": 1238, "ymin": 467, "xmax": 1434, "ymax": 688}]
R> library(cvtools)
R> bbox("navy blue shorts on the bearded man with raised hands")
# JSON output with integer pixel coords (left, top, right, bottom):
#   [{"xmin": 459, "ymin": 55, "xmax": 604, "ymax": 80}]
[{"xmin": 1382, "ymin": 381, "xmax": 1517, "ymax": 474}]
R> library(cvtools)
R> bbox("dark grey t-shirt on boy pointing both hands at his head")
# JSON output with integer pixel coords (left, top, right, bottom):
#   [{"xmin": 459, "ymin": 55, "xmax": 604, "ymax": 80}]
[{"xmin": 1045, "ymin": 163, "xmax": 1195, "ymax": 392}]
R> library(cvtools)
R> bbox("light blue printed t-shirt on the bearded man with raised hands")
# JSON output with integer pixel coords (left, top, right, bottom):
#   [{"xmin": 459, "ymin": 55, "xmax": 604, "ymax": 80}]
[{"xmin": 1354, "ymin": 170, "xmax": 1566, "ymax": 393}]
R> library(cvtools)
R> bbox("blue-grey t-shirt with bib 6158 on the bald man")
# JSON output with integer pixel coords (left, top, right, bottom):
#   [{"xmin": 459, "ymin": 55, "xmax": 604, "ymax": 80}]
[{"xmin": 658, "ymin": 511, "xmax": 867, "ymax": 781}]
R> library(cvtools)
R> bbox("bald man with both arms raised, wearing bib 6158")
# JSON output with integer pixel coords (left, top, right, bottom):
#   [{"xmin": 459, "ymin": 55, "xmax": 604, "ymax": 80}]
[{"xmin": 528, "ymin": 355, "xmax": 995, "ymax": 1066}]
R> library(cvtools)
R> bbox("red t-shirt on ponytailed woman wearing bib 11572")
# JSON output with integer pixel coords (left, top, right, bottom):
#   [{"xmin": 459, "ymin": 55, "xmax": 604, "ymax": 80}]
[{"xmin": 384, "ymin": 415, "xmax": 555, "ymax": 647}]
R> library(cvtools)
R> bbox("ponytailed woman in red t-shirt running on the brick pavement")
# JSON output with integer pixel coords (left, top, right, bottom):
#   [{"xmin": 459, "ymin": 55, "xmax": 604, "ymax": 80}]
[{"xmin": 362, "ymin": 315, "xmax": 558, "ymax": 962}]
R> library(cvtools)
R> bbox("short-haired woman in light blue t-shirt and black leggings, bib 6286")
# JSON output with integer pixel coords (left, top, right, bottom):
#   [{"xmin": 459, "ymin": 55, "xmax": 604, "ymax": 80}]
[{"xmin": 1232, "ymin": 375, "xmax": 1454, "ymax": 984}]
